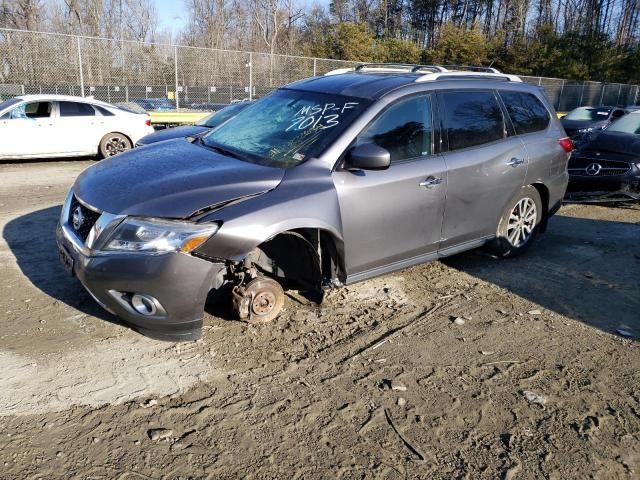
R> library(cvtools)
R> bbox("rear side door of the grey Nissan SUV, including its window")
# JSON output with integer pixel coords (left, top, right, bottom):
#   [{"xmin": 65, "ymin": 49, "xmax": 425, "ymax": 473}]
[{"xmin": 438, "ymin": 90, "xmax": 528, "ymax": 254}]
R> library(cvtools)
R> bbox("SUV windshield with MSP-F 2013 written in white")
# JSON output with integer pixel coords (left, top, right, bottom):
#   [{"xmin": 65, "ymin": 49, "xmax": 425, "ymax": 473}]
[{"xmin": 202, "ymin": 89, "xmax": 369, "ymax": 168}]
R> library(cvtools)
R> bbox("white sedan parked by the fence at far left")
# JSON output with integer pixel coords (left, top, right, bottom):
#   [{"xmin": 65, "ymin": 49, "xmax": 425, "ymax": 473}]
[{"xmin": 0, "ymin": 95, "xmax": 153, "ymax": 160}]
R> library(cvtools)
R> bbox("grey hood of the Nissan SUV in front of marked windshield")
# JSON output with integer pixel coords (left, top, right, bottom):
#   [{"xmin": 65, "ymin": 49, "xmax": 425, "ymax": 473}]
[{"xmin": 73, "ymin": 139, "xmax": 284, "ymax": 218}]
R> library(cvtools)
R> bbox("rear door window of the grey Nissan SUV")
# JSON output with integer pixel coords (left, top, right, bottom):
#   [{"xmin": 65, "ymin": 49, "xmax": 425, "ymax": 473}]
[{"xmin": 442, "ymin": 91, "xmax": 505, "ymax": 151}]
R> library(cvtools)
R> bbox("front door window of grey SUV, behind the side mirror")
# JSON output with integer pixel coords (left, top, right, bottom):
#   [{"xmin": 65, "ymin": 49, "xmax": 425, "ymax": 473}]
[{"xmin": 356, "ymin": 96, "xmax": 432, "ymax": 163}]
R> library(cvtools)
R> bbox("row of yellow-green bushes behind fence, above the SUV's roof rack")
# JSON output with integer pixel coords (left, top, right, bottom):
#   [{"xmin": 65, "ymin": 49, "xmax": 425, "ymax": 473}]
[{"xmin": 302, "ymin": 12, "xmax": 640, "ymax": 83}]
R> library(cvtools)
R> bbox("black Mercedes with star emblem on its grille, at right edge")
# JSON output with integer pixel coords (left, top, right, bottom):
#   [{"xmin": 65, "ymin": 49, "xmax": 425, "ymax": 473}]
[{"xmin": 568, "ymin": 111, "xmax": 640, "ymax": 199}]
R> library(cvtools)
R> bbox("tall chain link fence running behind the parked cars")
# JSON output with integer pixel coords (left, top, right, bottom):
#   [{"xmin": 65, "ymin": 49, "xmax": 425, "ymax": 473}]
[{"xmin": 0, "ymin": 29, "xmax": 640, "ymax": 111}]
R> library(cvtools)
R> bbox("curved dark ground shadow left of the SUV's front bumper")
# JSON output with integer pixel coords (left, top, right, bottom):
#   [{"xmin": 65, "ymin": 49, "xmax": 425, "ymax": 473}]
[{"xmin": 2, "ymin": 205, "xmax": 127, "ymax": 325}]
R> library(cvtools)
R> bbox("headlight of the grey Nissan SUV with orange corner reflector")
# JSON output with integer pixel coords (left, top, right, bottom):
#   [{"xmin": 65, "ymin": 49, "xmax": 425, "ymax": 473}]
[{"xmin": 102, "ymin": 217, "xmax": 219, "ymax": 253}]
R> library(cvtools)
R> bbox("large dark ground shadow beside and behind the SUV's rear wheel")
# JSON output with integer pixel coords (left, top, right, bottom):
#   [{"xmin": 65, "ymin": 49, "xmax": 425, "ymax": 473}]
[{"xmin": 445, "ymin": 215, "xmax": 640, "ymax": 340}]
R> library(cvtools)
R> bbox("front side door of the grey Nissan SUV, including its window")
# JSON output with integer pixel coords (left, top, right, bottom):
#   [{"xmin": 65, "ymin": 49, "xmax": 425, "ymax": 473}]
[{"xmin": 333, "ymin": 95, "xmax": 447, "ymax": 282}]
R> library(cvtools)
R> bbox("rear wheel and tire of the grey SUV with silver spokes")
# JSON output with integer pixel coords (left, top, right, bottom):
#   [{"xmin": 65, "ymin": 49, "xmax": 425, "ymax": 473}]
[{"xmin": 487, "ymin": 186, "xmax": 544, "ymax": 258}]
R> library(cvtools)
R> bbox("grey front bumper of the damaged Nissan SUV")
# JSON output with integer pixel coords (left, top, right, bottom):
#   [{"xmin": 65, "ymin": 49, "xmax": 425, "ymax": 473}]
[{"xmin": 56, "ymin": 212, "xmax": 225, "ymax": 341}]
